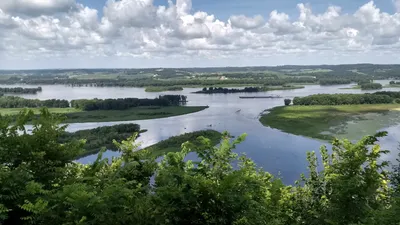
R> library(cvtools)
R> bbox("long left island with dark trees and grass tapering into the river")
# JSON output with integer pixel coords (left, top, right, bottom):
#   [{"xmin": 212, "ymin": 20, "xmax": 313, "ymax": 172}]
[{"xmin": 0, "ymin": 95, "xmax": 208, "ymax": 123}]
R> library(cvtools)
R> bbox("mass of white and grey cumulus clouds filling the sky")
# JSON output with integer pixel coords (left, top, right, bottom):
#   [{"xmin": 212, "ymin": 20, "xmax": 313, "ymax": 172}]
[{"xmin": 0, "ymin": 0, "xmax": 400, "ymax": 68}]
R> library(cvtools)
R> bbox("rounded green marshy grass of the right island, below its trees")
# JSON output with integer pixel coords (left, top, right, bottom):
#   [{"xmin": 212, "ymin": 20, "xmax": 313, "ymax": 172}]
[{"xmin": 260, "ymin": 104, "xmax": 400, "ymax": 140}]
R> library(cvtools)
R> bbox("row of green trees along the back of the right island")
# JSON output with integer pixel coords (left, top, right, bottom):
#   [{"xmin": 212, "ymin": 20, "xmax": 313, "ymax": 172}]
[{"xmin": 293, "ymin": 94, "xmax": 395, "ymax": 105}]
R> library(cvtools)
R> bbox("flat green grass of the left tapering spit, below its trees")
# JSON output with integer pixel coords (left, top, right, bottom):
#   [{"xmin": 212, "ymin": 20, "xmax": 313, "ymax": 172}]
[{"xmin": 0, "ymin": 106, "xmax": 208, "ymax": 123}]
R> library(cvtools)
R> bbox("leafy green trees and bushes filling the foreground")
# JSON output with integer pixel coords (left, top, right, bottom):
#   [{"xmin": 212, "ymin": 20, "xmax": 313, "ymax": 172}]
[{"xmin": 0, "ymin": 109, "xmax": 400, "ymax": 225}]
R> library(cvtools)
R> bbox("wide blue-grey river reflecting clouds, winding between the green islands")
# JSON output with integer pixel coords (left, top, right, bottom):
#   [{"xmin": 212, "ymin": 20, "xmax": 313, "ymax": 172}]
[{"xmin": 3, "ymin": 81, "xmax": 400, "ymax": 183}]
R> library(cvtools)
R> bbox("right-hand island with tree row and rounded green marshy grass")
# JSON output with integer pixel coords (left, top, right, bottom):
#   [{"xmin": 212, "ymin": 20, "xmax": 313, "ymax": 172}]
[{"xmin": 259, "ymin": 92, "xmax": 400, "ymax": 140}]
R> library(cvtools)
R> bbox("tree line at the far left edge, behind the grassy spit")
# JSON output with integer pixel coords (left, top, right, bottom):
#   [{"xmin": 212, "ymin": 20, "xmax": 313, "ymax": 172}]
[{"xmin": 0, "ymin": 96, "xmax": 69, "ymax": 108}]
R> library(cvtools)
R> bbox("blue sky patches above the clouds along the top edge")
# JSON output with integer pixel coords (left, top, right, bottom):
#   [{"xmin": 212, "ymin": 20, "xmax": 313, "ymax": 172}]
[{"xmin": 78, "ymin": 0, "xmax": 394, "ymax": 20}]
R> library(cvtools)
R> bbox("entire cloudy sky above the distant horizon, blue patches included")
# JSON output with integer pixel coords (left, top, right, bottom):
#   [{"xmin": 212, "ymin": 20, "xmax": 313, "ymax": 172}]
[{"xmin": 0, "ymin": 0, "xmax": 400, "ymax": 69}]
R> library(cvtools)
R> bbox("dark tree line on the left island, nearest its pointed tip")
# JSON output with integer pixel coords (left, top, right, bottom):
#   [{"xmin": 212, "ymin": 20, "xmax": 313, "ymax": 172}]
[{"xmin": 71, "ymin": 95, "xmax": 187, "ymax": 111}]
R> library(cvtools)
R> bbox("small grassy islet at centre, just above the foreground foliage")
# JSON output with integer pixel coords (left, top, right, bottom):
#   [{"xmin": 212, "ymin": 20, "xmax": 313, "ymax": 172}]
[{"xmin": 144, "ymin": 130, "xmax": 222, "ymax": 157}]
